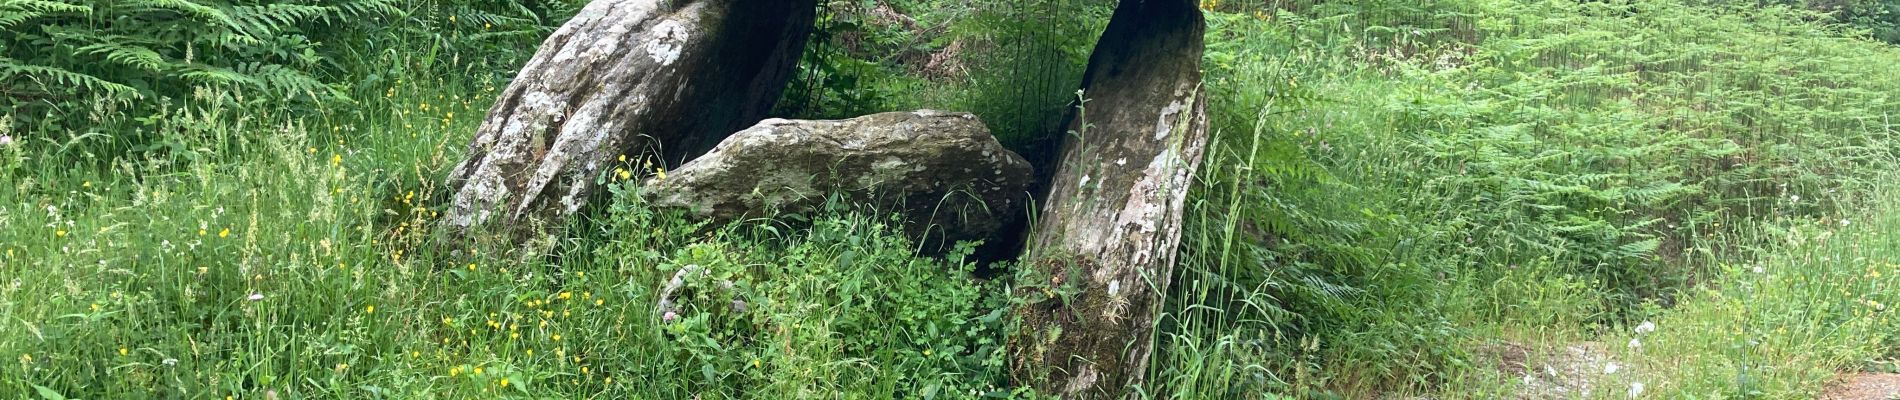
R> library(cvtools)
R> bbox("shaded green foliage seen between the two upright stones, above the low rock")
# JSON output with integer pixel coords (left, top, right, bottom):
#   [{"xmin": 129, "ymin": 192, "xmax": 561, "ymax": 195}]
[{"xmin": 777, "ymin": 0, "xmax": 1113, "ymax": 154}]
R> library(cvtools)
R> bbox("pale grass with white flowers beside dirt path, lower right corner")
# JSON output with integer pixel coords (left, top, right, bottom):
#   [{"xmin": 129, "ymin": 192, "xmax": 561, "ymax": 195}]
[{"xmin": 1607, "ymin": 180, "xmax": 1900, "ymax": 398}]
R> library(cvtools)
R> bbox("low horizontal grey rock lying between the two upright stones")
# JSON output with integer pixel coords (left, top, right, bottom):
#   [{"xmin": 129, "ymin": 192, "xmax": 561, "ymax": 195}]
[{"xmin": 646, "ymin": 110, "xmax": 1034, "ymax": 250}]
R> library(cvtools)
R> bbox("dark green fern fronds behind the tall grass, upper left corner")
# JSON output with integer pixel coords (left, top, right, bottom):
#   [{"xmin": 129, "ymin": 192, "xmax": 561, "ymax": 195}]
[{"xmin": 0, "ymin": 0, "xmax": 578, "ymax": 157}]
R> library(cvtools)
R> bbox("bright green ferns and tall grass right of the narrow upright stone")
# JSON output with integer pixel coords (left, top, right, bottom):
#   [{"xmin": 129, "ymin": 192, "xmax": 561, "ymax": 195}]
[{"xmin": 1151, "ymin": 0, "xmax": 1900, "ymax": 398}]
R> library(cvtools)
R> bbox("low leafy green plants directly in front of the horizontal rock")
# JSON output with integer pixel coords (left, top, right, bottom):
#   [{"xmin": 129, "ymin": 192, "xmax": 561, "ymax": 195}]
[{"xmin": 581, "ymin": 186, "xmax": 1033, "ymax": 398}]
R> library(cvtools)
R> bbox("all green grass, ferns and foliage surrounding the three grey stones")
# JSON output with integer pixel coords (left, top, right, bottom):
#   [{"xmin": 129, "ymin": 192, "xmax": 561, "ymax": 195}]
[{"xmin": 0, "ymin": 0, "xmax": 1900, "ymax": 398}]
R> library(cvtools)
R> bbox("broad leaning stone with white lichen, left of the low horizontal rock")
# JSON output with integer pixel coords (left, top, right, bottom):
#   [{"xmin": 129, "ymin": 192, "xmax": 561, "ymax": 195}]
[{"xmin": 445, "ymin": 0, "xmax": 815, "ymax": 241}]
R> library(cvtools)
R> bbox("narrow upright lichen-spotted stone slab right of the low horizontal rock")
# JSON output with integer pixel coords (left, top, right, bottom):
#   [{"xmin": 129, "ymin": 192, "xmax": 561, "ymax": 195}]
[{"xmin": 1011, "ymin": 0, "xmax": 1207, "ymax": 398}]
